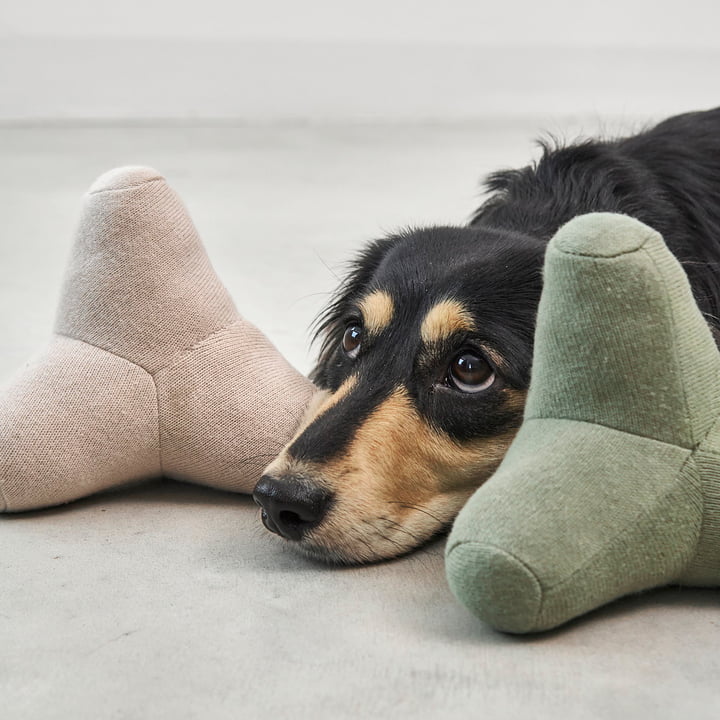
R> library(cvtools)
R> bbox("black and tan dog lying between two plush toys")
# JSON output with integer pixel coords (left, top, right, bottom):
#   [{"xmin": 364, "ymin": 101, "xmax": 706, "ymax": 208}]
[{"xmin": 254, "ymin": 108, "xmax": 720, "ymax": 564}]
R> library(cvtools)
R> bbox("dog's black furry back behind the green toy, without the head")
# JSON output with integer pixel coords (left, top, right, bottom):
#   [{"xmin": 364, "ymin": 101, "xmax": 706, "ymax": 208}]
[{"xmin": 471, "ymin": 108, "xmax": 720, "ymax": 326}]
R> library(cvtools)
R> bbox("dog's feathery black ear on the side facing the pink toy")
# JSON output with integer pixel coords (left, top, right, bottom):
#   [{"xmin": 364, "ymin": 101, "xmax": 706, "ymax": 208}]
[{"xmin": 310, "ymin": 237, "xmax": 397, "ymax": 388}]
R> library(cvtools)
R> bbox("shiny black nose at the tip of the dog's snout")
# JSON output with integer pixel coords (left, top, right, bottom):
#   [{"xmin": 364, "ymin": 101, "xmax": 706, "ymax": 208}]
[{"xmin": 253, "ymin": 475, "xmax": 332, "ymax": 540}]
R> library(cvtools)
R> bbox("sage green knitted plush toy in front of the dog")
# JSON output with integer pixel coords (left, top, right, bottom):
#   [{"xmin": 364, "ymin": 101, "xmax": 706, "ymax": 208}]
[{"xmin": 446, "ymin": 213, "xmax": 720, "ymax": 633}]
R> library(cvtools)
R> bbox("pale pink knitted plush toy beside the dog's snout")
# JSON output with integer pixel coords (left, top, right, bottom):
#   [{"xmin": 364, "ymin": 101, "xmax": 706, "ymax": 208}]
[{"xmin": 0, "ymin": 167, "xmax": 313, "ymax": 511}]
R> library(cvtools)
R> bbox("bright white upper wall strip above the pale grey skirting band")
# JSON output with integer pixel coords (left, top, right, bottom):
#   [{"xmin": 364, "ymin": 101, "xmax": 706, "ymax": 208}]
[{"xmin": 5, "ymin": 0, "xmax": 719, "ymax": 48}]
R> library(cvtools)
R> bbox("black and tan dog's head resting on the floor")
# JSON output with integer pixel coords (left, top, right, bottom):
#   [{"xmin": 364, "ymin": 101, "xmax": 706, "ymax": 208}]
[{"xmin": 254, "ymin": 227, "xmax": 544, "ymax": 563}]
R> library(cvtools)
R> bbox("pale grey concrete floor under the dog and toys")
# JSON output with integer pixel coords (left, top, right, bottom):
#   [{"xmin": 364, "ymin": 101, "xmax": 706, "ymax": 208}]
[{"xmin": 0, "ymin": 118, "xmax": 720, "ymax": 720}]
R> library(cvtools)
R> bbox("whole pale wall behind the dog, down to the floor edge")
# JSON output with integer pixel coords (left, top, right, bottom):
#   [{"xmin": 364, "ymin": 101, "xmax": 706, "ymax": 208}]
[{"xmin": 0, "ymin": 0, "xmax": 720, "ymax": 121}]
